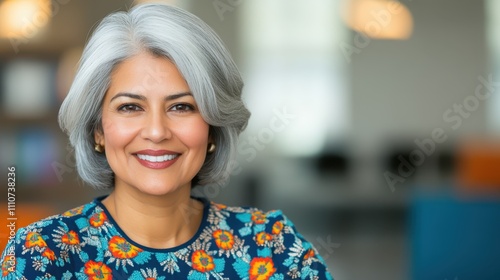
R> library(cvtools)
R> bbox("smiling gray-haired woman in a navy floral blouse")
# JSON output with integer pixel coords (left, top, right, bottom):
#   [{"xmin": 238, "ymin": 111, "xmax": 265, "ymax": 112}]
[{"xmin": 2, "ymin": 4, "xmax": 331, "ymax": 279}]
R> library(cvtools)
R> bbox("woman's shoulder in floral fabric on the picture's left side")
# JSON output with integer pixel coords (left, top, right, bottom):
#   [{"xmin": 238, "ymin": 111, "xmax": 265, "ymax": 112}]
[{"xmin": 2, "ymin": 202, "xmax": 102, "ymax": 279}]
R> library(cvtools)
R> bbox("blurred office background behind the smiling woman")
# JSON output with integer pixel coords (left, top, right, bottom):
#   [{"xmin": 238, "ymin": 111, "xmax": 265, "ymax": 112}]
[{"xmin": 0, "ymin": 0, "xmax": 500, "ymax": 280}]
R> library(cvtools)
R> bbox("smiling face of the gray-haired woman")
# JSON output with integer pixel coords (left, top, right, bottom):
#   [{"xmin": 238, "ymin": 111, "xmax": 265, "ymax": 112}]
[{"xmin": 95, "ymin": 53, "xmax": 209, "ymax": 195}]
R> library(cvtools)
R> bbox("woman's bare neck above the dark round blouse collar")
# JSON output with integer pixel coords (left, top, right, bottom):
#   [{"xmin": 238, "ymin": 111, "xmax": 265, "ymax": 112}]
[{"xmin": 102, "ymin": 188, "xmax": 203, "ymax": 249}]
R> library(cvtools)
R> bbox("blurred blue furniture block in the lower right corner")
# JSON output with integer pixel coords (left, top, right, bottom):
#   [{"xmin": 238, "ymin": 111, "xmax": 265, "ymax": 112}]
[{"xmin": 410, "ymin": 192, "xmax": 500, "ymax": 280}]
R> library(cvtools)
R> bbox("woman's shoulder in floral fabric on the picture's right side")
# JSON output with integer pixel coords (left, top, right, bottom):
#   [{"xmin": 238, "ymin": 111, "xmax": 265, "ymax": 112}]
[{"xmin": 208, "ymin": 202, "xmax": 332, "ymax": 279}]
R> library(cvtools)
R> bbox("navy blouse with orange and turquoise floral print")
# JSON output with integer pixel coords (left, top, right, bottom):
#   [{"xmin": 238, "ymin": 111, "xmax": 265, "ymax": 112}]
[{"xmin": 1, "ymin": 197, "xmax": 332, "ymax": 280}]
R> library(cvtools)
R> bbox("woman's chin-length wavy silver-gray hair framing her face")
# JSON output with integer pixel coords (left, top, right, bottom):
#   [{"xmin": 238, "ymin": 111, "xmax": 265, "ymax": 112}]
[{"xmin": 59, "ymin": 4, "xmax": 250, "ymax": 189}]
